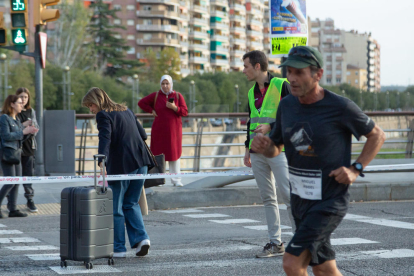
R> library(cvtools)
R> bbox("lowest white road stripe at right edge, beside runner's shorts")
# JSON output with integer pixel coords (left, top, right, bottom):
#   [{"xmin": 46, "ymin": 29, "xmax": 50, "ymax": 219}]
[{"xmin": 336, "ymin": 249, "xmax": 414, "ymax": 260}]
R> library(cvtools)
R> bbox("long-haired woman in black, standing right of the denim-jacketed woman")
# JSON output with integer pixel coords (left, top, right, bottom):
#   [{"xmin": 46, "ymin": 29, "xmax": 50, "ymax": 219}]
[{"xmin": 16, "ymin": 87, "xmax": 39, "ymax": 213}]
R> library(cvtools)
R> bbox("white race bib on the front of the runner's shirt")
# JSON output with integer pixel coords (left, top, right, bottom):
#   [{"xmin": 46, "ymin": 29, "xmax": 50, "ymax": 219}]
[{"xmin": 289, "ymin": 167, "xmax": 322, "ymax": 200}]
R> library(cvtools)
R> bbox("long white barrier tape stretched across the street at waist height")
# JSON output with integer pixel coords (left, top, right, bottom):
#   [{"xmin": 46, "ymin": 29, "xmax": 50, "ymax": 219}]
[{"xmin": 0, "ymin": 164, "xmax": 414, "ymax": 185}]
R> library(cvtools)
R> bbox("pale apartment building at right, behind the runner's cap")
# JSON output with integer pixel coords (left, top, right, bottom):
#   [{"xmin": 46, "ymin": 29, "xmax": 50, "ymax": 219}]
[{"xmin": 308, "ymin": 18, "xmax": 381, "ymax": 92}]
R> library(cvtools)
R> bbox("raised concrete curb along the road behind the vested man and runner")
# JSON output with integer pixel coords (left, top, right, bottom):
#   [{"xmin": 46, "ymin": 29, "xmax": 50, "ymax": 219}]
[{"xmin": 147, "ymin": 182, "xmax": 414, "ymax": 210}]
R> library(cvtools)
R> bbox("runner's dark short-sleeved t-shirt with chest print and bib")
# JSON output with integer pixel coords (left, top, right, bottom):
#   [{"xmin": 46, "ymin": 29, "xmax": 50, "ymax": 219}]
[{"xmin": 270, "ymin": 89, "xmax": 375, "ymax": 219}]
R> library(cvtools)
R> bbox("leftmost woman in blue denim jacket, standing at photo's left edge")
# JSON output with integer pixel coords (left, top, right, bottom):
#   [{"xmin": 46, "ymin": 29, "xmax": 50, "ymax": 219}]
[{"xmin": 0, "ymin": 95, "xmax": 38, "ymax": 218}]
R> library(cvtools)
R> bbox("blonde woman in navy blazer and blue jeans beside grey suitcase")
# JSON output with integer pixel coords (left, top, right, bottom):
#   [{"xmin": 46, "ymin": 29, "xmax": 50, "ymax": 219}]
[{"xmin": 82, "ymin": 87, "xmax": 154, "ymax": 258}]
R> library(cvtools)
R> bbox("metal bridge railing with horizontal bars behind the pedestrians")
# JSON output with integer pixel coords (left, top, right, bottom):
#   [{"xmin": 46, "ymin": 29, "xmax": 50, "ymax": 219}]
[{"xmin": 76, "ymin": 112, "xmax": 414, "ymax": 173}]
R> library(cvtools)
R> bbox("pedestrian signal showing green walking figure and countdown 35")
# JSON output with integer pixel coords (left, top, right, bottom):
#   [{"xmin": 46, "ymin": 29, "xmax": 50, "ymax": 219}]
[{"xmin": 10, "ymin": 0, "xmax": 28, "ymax": 45}]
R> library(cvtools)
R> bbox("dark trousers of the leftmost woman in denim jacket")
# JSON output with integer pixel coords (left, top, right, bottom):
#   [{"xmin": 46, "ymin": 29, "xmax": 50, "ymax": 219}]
[{"xmin": 0, "ymin": 156, "xmax": 22, "ymax": 211}]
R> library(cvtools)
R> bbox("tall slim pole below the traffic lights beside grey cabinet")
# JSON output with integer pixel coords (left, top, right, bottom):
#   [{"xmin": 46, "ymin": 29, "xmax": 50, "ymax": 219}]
[{"xmin": 34, "ymin": 25, "xmax": 45, "ymax": 176}]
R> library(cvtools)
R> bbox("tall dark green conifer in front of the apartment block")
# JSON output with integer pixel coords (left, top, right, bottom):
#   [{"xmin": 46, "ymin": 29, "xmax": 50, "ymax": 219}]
[{"xmin": 88, "ymin": 0, "xmax": 142, "ymax": 77}]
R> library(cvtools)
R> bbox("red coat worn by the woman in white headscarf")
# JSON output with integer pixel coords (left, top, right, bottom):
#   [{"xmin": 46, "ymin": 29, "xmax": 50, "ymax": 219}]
[{"xmin": 138, "ymin": 90, "xmax": 188, "ymax": 161}]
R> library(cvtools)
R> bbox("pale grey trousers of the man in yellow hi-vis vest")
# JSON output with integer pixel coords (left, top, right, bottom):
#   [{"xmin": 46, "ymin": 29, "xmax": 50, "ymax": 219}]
[{"xmin": 250, "ymin": 152, "xmax": 295, "ymax": 244}]
